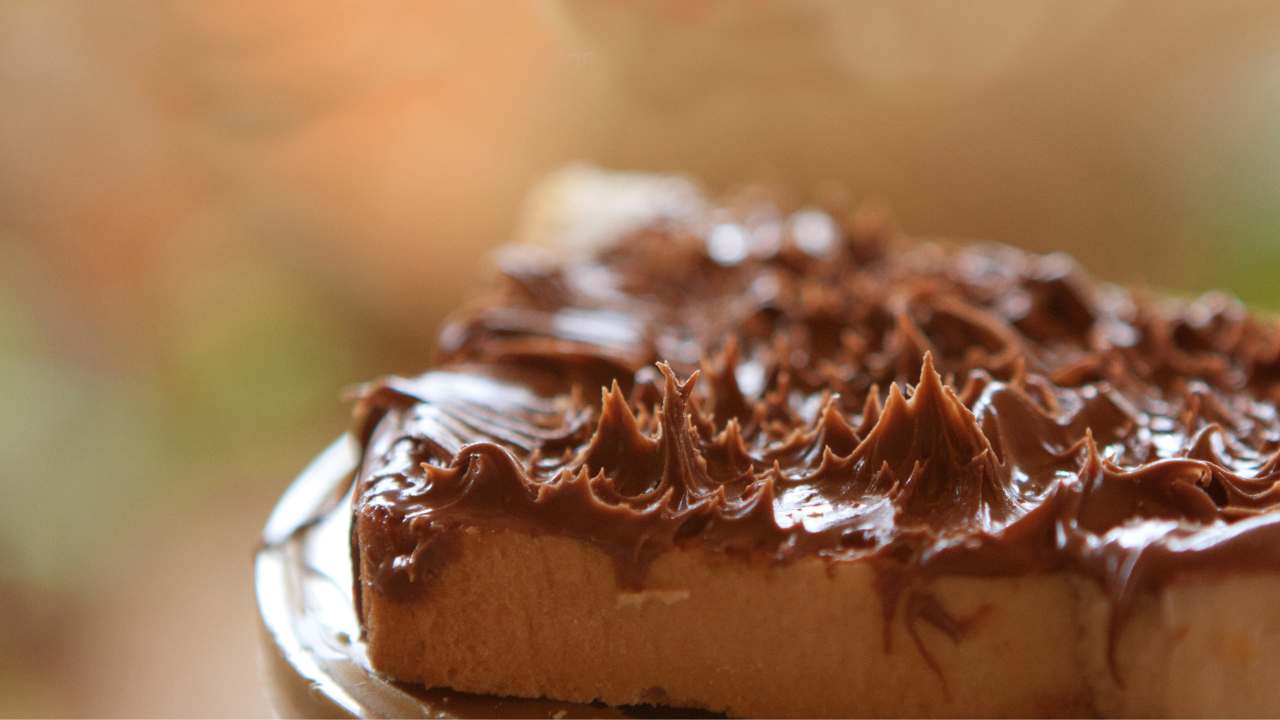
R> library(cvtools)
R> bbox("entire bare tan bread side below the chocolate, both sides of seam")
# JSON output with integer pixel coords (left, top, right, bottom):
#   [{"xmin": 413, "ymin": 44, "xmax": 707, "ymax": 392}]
[{"xmin": 361, "ymin": 517, "xmax": 1280, "ymax": 717}]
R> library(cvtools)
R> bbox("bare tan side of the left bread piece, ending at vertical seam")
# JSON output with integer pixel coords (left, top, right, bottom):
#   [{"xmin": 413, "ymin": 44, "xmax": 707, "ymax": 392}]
[{"xmin": 362, "ymin": 529, "xmax": 1091, "ymax": 716}]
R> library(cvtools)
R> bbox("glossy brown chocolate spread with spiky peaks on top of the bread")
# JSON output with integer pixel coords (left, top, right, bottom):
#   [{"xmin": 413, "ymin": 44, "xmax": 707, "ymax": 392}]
[{"xmin": 355, "ymin": 197, "xmax": 1280, "ymax": 666}]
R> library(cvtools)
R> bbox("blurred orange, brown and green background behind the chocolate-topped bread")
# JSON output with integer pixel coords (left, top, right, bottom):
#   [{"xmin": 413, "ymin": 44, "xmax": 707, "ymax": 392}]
[{"xmin": 0, "ymin": 0, "xmax": 1280, "ymax": 716}]
